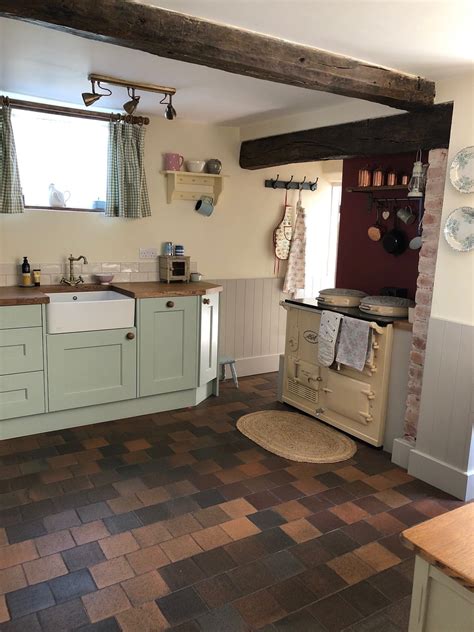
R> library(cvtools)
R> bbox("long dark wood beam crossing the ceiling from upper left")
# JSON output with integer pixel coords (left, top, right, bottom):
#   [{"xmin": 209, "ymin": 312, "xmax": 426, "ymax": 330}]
[{"xmin": 0, "ymin": 0, "xmax": 435, "ymax": 110}]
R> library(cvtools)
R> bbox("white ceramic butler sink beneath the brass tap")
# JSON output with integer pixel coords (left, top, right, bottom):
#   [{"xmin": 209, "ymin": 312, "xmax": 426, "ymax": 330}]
[{"xmin": 46, "ymin": 290, "xmax": 135, "ymax": 334}]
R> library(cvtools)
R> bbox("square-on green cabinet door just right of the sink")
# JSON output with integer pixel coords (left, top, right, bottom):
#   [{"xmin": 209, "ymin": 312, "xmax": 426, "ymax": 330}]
[{"xmin": 138, "ymin": 296, "xmax": 199, "ymax": 397}]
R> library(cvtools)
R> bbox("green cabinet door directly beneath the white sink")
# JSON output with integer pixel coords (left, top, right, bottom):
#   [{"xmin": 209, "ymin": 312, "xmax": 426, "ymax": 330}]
[{"xmin": 46, "ymin": 327, "xmax": 137, "ymax": 411}]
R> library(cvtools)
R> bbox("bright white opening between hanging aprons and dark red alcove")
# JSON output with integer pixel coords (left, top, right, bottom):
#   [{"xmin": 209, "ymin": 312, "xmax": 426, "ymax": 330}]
[{"xmin": 301, "ymin": 184, "xmax": 342, "ymax": 298}]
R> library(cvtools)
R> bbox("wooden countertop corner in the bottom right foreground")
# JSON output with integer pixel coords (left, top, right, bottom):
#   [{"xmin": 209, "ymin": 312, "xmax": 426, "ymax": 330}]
[{"xmin": 402, "ymin": 503, "xmax": 474, "ymax": 591}]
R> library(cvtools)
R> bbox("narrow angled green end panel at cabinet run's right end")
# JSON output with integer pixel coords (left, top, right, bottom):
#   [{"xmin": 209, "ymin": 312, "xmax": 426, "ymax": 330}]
[{"xmin": 199, "ymin": 292, "xmax": 219, "ymax": 386}]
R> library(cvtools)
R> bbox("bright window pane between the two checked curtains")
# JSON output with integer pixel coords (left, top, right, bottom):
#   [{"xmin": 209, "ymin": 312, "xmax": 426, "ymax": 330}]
[{"xmin": 12, "ymin": 109, "xmax": 108, "ymax": 210}]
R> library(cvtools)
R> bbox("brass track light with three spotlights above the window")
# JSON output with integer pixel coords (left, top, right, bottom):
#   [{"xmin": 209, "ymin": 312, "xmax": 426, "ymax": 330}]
[{"xmin": 82, "ymin": 74, "xmax": 177, "ymax": 121}]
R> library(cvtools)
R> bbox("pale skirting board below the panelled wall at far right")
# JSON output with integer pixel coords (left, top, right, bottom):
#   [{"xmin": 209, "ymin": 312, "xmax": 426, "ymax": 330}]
[{"xmin": 408, "ymin": 449, "xmax": 474, "ymax": 501}]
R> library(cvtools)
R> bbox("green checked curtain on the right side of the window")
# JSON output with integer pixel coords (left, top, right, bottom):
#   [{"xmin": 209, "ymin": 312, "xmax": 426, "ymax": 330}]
[{"xmin": 105, "ymin": 121, "xmax": 151, "ymax": 219}]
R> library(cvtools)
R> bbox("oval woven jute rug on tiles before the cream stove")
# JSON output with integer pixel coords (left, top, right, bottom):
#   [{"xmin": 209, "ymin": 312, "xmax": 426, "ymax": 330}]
[{"xmin": 237, "ymin": 410, "xmax": 357, "ymax": 463}]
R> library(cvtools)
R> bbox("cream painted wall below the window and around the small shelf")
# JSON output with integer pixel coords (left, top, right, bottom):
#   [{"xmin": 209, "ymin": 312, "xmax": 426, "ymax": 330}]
[{"xmin": 0, "ymin": 117, "xmax": 339, "ymax": 279}]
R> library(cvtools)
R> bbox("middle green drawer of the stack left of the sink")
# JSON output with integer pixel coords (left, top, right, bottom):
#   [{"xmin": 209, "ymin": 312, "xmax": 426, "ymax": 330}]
[{"xmin": 0, "ymin": 327, "xmax": 43, "ymax": 375}]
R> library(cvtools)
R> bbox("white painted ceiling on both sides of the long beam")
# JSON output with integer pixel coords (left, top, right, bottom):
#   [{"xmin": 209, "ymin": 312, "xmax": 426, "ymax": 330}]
[{"xmin": 0, "ymin": 0, "xmax": 474, "ymax": 124}]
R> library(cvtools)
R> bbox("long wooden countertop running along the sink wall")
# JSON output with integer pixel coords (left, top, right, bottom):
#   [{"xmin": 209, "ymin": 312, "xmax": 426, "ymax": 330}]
[{"xmin": 0, "ymin": 281, "xmax": 223, "ymax": 307}]
